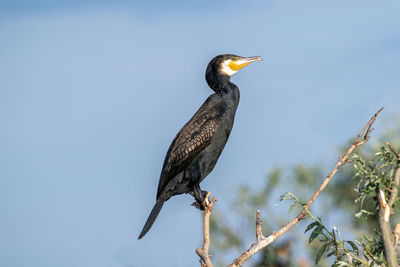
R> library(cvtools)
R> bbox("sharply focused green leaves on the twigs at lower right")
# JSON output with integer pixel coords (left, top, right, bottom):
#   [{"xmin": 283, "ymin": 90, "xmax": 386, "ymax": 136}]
[{"xmin": 281, "ymin": 143, "xmax": 399, "ymax": 266}]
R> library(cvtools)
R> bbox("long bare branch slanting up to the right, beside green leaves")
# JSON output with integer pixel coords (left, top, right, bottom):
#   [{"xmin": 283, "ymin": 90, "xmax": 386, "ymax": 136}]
[{"xmin": 229, "ymin": 107, "xmax": 385, "ymax": 267}]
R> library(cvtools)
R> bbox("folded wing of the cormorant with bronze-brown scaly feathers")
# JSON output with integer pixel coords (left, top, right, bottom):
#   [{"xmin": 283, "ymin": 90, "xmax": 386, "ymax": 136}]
[{"xmin": 157, "ymin": 97, "xmax": 221, "ymax": 199}]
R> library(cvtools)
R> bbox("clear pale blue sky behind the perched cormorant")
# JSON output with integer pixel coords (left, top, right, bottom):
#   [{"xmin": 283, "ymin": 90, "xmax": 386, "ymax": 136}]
[{"xmin": 0, "ymin": 1, "xmax": 400, "ymax": 267}]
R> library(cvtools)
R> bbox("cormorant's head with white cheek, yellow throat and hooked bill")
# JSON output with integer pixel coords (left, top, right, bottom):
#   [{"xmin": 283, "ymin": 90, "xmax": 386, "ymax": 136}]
[{"xmin": 206, "ymin": 54, "xmax": 262, "ymax": 91}]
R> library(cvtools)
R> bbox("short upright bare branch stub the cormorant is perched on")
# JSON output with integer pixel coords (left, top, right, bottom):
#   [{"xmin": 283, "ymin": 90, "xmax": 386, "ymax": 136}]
[{"xmin": 196, "ymin": 192, "xmax": 217, "ymax": 267}]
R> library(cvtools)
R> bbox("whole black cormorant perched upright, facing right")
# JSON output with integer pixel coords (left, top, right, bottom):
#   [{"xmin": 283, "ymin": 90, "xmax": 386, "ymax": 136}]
[{"xmin": 138, "ymin": 54, "xmax": 262, "ymax": 239}]
